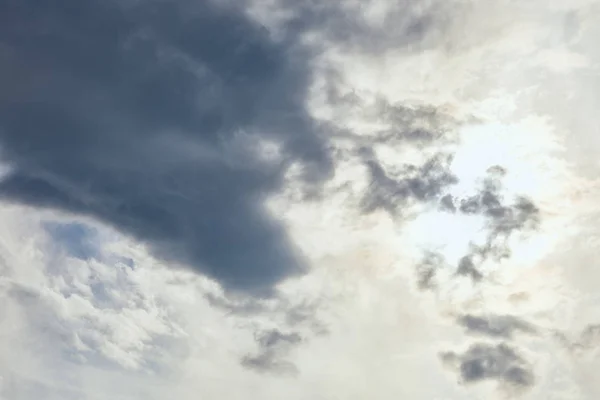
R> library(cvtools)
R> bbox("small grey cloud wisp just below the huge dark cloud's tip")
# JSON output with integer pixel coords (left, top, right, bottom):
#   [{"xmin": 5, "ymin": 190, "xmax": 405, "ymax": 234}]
[{"xmin": 241, "ymin": 329, "xmax": 302, "ymax": 374}]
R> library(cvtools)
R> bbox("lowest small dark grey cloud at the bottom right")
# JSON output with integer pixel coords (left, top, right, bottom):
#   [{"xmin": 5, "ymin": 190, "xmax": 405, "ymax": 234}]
[{"xmin": 441, "ymin": 343, "xmax": 535, "ymax": 388}]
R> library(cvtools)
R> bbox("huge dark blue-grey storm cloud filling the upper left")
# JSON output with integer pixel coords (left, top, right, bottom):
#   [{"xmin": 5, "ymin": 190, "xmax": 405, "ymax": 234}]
[{"xmin": 0, "ymin": 0, "xmax": 331, "ymax": 291}]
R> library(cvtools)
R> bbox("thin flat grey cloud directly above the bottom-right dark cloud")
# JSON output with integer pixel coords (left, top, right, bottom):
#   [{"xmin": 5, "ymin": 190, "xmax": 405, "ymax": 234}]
[{"xmin": 458, "ymin": 314, "xmax": 535, "ymax": 339}]
